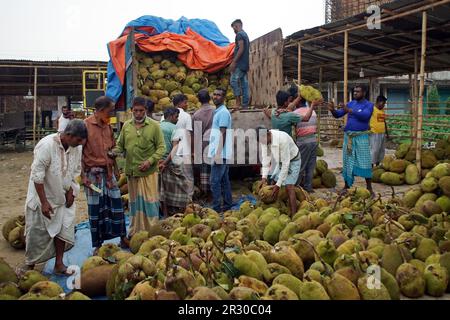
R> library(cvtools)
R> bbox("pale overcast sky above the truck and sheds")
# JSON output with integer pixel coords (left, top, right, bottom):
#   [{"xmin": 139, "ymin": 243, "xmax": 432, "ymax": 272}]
[{"xmin": 0, "ymin": 0, "xmax": 324, "ymax": 61}]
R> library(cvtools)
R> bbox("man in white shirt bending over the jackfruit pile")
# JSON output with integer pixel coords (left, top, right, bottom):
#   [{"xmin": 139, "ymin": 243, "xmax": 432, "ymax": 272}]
[{"xmin": 257, "ymin": 127, "xmax": 301, "ymax": 215}]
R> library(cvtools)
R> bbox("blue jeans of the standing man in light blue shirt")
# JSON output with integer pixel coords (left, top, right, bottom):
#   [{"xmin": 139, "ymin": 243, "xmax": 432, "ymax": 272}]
[{"xmin": 211, "ymin": 160, "xmax": 233, "ymax": 213}]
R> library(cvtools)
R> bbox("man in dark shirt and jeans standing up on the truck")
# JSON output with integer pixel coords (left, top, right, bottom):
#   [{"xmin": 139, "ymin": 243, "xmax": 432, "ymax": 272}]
[{"xmin": 230, "ymin": 19, "xmax": 250, "ymax": 109}]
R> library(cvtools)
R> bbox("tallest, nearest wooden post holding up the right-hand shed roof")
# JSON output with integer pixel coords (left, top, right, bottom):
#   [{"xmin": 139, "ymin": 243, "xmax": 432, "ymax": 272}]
[{"xmin": 416, "ymin": 11, "xmax": 427, "ymax": 174}]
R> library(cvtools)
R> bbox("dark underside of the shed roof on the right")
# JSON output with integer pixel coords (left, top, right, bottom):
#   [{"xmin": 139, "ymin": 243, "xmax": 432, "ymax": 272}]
[{"xmin": 283, "ymin": 0, "xmax": 450, "ymax": 83}]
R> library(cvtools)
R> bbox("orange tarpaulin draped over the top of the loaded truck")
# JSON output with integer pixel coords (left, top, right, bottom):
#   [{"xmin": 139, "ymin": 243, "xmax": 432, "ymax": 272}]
[{"xmin": 108, "ymin": 29, "xmax": 235, "ymax": 84}]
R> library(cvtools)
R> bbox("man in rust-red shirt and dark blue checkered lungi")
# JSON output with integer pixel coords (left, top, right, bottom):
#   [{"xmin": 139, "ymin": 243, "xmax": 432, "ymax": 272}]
[{"xmin": 81, "ymin": 97, "xmax": 129, "ymax": 254}]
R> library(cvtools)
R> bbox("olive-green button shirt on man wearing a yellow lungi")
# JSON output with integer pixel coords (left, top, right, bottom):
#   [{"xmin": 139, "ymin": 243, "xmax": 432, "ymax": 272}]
[{"xmin": 114, "ymin": 118, "xmax": 166, "ymax": 177}]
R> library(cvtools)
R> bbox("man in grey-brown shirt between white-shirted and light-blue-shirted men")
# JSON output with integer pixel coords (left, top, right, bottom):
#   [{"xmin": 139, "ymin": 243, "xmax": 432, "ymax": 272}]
[{"xmin": 192, "ymin": 89, "xmax": 215, "ymax": 195}]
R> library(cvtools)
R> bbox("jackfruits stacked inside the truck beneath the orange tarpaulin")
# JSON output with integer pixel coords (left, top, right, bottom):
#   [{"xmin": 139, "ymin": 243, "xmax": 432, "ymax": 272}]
[{"xmin": 136, "ymin": 51, "xmax": 235, "ymax": 112}]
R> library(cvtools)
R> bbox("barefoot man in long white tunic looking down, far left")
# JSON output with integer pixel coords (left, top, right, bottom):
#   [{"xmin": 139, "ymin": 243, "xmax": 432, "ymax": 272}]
[{"xmin": 25, "ymin": 120, "xmax": 87, "ymax": 274}]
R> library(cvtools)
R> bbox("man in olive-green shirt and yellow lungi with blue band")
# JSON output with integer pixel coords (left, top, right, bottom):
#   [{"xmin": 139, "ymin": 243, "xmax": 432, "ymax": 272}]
[{"xmin": 114, "ymin": 97, "xmax": 165, "ymax": 238}]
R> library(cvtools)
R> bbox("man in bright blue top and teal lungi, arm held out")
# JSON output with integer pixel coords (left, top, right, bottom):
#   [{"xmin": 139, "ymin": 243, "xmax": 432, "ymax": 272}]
[{"xmin": 329, "ymin": 86, "xmax": 374, "ymax": 196}]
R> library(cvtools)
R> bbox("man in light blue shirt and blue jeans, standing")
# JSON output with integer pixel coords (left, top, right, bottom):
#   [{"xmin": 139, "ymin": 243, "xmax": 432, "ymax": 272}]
[{"xmin": 208, "ymin": 88, "xmax": 233, "ymax": 213}]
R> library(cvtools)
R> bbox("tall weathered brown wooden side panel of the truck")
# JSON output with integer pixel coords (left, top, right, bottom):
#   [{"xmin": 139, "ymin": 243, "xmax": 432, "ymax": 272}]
[{"xmin": 248, "ymin": 29, "xmax": 284, "ymax": 107}]
